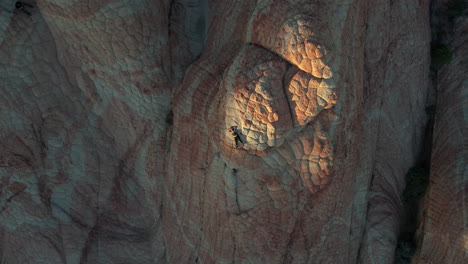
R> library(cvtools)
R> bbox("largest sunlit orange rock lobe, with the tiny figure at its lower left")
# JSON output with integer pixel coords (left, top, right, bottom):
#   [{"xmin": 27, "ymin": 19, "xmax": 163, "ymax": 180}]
[{"xmin": 224, "ymin": 46, "xmax": 292, "ymax": 151}]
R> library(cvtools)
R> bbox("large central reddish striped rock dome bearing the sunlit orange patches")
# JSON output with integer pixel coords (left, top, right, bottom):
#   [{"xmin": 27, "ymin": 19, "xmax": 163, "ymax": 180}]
[{"xmin": 163, "ymin": 1, "xmax": 429, "ymax": 263}]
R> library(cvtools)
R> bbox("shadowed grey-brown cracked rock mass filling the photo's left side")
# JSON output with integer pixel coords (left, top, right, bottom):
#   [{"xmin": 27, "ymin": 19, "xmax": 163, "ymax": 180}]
[{"xmin": 0, "ymin": 1, "xmax": 170, "ymax": 263}]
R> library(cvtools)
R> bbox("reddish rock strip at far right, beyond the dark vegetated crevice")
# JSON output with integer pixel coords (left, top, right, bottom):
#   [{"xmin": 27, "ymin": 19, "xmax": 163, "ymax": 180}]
[{"xmin": 416, "ymin": 14, "xmax": 468, "ymax": 263}]
